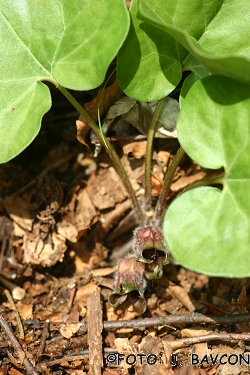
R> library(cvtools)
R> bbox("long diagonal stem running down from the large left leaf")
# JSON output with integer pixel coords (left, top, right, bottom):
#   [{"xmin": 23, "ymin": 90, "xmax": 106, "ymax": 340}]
[{"xmin": 57, "ymin": 85, "xmax": 144, "ymax": 225}]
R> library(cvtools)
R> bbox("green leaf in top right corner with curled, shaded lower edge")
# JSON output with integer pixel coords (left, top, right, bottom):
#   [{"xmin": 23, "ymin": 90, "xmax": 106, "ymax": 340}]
[{"xmin": 139, "ymin": 0, "xmax": 250, "ymax": 83}]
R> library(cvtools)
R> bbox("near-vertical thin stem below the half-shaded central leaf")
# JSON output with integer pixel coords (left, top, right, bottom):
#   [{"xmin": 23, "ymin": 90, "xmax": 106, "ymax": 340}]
[{"xmin": 145, "ymin": 98, "xmax": 165, "ymax": 222}]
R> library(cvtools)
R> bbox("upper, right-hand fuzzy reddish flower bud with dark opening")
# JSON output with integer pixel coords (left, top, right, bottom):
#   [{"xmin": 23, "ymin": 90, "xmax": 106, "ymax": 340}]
[{"xmin": 133, "ymin": 225, "xmax": 171, "ymax": 280}]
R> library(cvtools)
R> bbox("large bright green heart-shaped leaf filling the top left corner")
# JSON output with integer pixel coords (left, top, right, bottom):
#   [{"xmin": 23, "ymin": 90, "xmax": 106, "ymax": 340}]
[{"xmin": 0, "ymin": 0, "xmax": 129, "ymax": 162}]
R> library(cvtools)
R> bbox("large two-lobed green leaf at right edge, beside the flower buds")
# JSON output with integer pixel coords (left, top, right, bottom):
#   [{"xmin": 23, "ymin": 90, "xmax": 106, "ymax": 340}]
[{"xmin": 163, "ymin": 75, "xmax": 250, "ymax": 277}]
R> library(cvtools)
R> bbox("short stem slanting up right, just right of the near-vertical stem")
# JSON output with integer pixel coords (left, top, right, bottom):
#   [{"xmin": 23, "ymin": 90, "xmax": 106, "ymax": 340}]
[{"xmin": 154, "ymin": 147, "xmax": 185, "ymax": 225}]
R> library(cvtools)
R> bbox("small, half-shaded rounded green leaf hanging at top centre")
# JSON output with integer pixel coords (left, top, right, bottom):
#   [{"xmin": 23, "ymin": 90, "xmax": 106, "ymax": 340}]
[{"xmin": 117, "ymin": 0, "xmax": 184, "ymax": 101}]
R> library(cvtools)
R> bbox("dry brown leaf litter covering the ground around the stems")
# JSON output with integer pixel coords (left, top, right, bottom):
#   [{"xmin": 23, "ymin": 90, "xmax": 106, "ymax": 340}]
[{"xmin": 0, "ymin": 84, "xmax": 250, "ymax": 375}]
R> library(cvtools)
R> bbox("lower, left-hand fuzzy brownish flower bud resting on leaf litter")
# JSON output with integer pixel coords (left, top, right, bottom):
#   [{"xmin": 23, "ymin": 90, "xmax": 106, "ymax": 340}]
[{"xmin": 109, "ymin": 257, "xmax": 147, "ymax": 315}]
